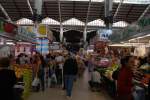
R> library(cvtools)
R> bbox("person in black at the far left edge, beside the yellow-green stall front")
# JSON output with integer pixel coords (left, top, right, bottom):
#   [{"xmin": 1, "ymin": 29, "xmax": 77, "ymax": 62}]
[{"xmin": 0, "ymin": 58, "xmax": 17, "ymax": 100}]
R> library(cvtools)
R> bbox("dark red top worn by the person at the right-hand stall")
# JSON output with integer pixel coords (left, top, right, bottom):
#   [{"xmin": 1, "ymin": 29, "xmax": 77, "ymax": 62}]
[{"xmin": 117, "ymin": 67, "xmax": 133, "ymax": 95}]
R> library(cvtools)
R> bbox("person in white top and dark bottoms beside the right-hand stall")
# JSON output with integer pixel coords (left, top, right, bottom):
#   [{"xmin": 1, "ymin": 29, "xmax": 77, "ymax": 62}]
[{"xmin": 89, "ymin": 69, "xmax": 101, "ymax": 91}]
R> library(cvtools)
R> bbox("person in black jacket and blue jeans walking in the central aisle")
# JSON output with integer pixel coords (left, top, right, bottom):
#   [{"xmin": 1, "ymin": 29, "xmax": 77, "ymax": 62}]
[{"xmin": 63, "ymin": 54, "xmax": 78, "ymax": 98}]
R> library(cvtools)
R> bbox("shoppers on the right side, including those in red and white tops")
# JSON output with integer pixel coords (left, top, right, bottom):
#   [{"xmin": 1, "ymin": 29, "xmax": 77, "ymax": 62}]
[{"xmin": 88, "ymin": 50, "xmax": 150, "ymax": 100}]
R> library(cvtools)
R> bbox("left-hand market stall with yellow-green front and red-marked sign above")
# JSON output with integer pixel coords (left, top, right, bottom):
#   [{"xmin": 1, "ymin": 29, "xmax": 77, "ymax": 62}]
[{"xmin": 0, "ymin": 19, "xmax": 35, "ymax": 99}]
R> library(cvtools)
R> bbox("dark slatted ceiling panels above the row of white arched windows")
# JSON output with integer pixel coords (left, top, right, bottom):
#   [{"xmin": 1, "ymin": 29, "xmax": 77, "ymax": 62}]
[{"xmin": 0, "ymin": 0, "xmax": 150, "ymax": 23}]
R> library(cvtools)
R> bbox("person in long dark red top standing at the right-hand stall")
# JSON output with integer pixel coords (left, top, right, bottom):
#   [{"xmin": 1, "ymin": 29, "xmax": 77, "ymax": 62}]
[{"xmin": 117, "ymin": 56, "xmax": 135, "ymax": 100}]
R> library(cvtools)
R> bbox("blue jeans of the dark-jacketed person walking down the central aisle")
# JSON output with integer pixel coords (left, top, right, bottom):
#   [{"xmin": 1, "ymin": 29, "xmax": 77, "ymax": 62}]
[{"xmin": 65, "ymin": 75, "xmax": 75, "ymax": 96}]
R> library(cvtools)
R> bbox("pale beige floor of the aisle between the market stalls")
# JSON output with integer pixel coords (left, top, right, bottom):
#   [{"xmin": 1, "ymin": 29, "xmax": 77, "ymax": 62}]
[{"xmin": 28, "ymin": 71, "xmax": 112, "ymax": 100}]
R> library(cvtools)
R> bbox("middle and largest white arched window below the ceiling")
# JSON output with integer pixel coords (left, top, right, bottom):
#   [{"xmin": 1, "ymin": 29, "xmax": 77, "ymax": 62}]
[{"xmin": 62, "ymin": 18, "xmax": 85, "ymax": 26}]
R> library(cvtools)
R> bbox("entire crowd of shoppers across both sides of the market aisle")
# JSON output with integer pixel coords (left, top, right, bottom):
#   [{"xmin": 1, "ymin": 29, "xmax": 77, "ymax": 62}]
[{"xmin": 0, "ymin": 47, "xmax": 150, "ymax": 100}]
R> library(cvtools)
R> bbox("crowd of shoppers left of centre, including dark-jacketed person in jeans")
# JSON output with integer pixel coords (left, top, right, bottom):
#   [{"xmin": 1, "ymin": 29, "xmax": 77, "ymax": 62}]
[{"xmin": 0, "ymin": 51, "xmax": 85, "ymax": 100}]
